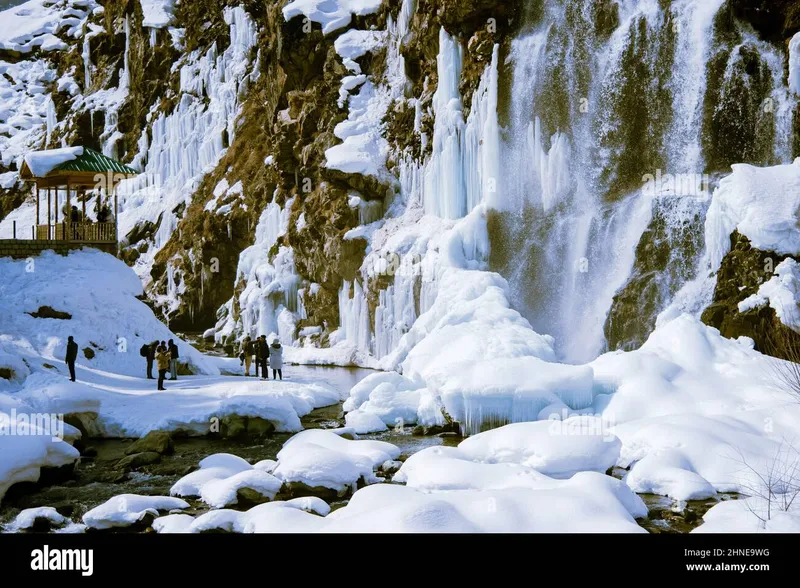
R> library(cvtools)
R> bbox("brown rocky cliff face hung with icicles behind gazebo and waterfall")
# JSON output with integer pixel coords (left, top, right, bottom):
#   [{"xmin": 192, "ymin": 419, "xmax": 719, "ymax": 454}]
[{"xmin": 0, "ymin": 0, "xmax": 800, "ymax": 366}]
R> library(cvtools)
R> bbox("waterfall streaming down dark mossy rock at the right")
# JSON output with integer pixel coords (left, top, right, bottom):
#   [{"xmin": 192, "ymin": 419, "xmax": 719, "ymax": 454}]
[{"xmin": 492, "ymin": 0, "xmax": 793, "ymax": 362}]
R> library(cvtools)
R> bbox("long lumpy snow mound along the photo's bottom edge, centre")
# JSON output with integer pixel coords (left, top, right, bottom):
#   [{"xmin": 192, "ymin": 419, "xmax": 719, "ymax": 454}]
[{"xmin": 157, "ymin": 474, "xmax": 647, "ymax": 533}]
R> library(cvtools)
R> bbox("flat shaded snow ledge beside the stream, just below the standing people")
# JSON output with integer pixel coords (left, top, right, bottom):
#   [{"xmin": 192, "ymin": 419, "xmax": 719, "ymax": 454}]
[{"xmin": 15, "ymin": 372, "xmax": 339, "ymax": 437}]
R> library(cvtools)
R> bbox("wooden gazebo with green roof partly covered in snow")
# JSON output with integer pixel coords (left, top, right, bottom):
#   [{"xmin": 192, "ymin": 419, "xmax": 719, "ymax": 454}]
[{"xmin": 20, "ymin": 147, "xmax": 138, "ymax": 245}]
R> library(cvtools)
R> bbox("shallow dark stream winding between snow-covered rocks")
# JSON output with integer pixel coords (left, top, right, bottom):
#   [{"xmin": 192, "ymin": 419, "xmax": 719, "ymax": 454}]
[{"xmin": 0, "ymin": 358, "xmax": 735, "ymax": 533}]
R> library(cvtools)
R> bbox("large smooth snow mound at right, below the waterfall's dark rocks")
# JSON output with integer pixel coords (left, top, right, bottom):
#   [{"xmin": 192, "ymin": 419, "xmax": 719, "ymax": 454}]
[{"xmin": 591, "ymin": 315, "xmax": 800, "ymax": 500}]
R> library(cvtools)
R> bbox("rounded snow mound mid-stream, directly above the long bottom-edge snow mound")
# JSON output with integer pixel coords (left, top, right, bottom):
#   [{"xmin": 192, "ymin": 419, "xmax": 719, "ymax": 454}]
[{"xmin": 273, "ymin": 429, "xmax": 400, "ymax": 493}]
